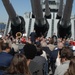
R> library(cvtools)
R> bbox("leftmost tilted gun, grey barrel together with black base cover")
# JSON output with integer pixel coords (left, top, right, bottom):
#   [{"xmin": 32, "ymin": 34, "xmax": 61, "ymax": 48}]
[{"xmin": 2, "ymin": 0, "xmax": 25, "ymax": 37}]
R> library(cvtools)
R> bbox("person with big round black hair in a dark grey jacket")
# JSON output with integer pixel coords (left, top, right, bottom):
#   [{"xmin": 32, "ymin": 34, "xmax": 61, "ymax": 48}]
[{"xmin": 23, "ymin": 43, "xmax": 42, "ymax": 75}]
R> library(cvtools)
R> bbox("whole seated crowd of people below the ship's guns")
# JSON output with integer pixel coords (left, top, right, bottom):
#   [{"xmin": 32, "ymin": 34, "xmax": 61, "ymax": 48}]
[{"xmin": 0, "ymin": 32, "xmax": 75, "ymax": 75}]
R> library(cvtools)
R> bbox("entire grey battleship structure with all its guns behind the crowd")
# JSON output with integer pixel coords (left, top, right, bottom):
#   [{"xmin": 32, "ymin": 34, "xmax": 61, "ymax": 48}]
[{"xmin": 2, "ymin": 0, "xmax": 75, "ymax": 38}]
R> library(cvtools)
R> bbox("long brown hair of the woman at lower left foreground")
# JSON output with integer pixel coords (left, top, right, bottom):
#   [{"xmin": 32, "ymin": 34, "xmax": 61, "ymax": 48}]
[{"xmin": 5, "ymin": 53, "xmax": 31, "ymax": 75}]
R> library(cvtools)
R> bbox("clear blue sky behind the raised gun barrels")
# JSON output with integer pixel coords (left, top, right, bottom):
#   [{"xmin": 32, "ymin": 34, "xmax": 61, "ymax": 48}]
[{"xmin": 0, "ymin": 0, "xmax": 75, "ymax": 23}]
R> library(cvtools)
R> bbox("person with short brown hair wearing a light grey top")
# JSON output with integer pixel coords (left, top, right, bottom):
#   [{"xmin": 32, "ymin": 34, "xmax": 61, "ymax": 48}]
[{"xmin": 54, "ymin": 47, "xmax": 73, "ymax": 75}]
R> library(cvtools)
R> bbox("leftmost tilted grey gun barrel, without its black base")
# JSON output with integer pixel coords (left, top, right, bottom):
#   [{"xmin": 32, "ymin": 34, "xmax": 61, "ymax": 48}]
[{"xmin": 2, "ymin": 0, "xmax": 20, "ymax": 23}]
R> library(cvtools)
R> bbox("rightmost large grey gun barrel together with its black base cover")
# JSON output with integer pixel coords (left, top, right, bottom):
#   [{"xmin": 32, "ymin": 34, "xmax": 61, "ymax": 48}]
[{"xmin": 57, "ymin": 0, "xmax": 73, "ymax": 38}]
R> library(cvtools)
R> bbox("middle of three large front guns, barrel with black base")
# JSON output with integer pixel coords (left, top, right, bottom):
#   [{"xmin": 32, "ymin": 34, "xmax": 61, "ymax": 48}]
[{"xmin": 32, "ymin": 0, "xmax": 49, "ymax": 37}]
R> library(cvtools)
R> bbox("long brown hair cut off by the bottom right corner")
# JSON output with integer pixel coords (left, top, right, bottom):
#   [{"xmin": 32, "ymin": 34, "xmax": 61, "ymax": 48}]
[{"xmin": 64, "ymin": 56, "xmax": 75, "ymax": 75}]
